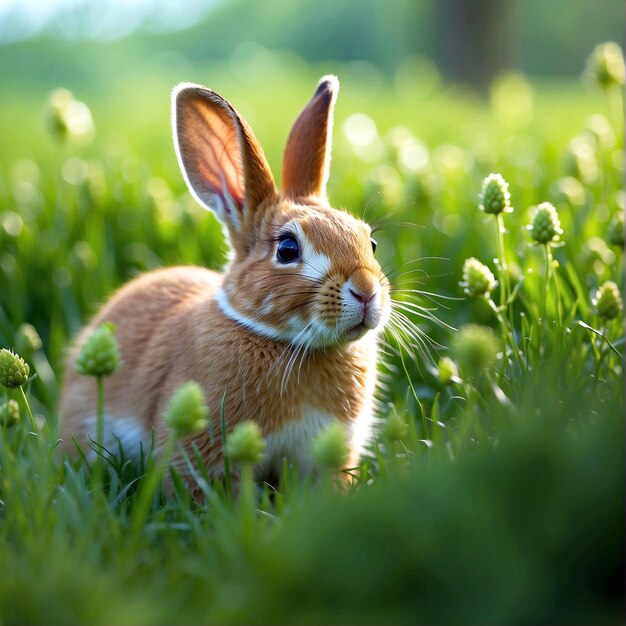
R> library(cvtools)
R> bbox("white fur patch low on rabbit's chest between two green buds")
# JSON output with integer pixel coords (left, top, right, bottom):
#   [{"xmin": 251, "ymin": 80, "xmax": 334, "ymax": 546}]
[{"xmin": 256, "ymin": 406, "xmax": 337, "ymax": 478}]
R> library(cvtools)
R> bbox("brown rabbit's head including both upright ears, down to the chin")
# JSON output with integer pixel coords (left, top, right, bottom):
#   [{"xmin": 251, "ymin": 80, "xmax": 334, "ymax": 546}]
[{"xmin": 172, "ymin": 76, "xmax": 389, "ymax": 347}]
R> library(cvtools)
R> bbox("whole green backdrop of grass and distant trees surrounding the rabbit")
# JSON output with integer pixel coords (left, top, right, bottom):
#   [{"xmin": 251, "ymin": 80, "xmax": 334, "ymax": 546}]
[{"xmin": 0, "ymin": 0, "xmax": 624, "ymax": 624}]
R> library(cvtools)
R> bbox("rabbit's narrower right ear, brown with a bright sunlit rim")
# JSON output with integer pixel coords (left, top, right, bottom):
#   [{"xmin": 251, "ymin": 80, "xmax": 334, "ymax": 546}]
[{"xmin": 283, "ymin": 76, "xmax": 339, "ymax": 198}]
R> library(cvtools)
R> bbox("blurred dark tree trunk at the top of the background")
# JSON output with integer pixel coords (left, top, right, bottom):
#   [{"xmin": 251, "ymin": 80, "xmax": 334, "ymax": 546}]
[{"xmin": 435, "ymin": 0, "xmax": 521, "ymax": 89}]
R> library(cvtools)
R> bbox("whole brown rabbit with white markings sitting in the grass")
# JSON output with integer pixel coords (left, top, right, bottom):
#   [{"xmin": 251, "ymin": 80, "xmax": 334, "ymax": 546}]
[{"xmin": 59, "ymin": 75, "xmax": 390, "ymax": 481}]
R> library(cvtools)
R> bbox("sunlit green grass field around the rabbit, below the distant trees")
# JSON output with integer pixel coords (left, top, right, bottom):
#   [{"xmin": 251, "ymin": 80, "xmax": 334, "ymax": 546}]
[{"xmin": 0, "ymin": 55, "xmax": 624, "ymax": 624}]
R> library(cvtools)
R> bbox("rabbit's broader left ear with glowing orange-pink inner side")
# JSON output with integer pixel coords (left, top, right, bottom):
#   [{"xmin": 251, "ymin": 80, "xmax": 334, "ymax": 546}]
[{"xmin": 172, "ymin": 83, "xmax": 277, "ymax": 251}]
